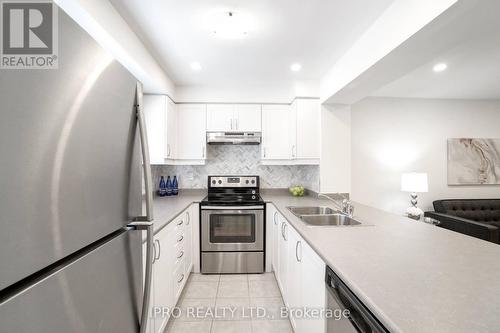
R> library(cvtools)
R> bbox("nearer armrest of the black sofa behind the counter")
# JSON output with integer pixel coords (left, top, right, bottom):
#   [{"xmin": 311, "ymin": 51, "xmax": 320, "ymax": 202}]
[{"xmin": 425, "ymin": 212, "xmax": 499, "ymax": 244}]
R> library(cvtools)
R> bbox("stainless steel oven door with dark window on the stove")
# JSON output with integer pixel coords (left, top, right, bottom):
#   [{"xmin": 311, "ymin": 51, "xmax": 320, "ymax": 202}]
[{"xmin": 201, "ymin": 206, "xmax": 264, "ymax": 251}]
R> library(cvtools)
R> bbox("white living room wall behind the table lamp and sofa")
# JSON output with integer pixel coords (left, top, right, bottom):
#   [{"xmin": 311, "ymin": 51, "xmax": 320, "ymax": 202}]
[{"xmin": 351, "ymin": 98, "xmax": 500, "ymax": 214}]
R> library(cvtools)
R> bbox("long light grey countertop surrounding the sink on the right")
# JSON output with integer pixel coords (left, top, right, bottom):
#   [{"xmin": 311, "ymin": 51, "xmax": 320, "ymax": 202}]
[{"xmin": 261, "ymin": 191, "xmax": 500, "ymax": 333}]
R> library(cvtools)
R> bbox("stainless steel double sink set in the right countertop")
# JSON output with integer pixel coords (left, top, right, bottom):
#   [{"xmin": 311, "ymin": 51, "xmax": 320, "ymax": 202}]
[{"xmin": 287, "ymin": 206, "xmax": 362, "ymax": 227}]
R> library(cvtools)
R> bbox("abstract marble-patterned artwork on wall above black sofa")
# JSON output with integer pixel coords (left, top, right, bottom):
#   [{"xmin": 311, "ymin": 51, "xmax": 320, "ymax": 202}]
[{"xmin": 448, "ymin": 138, "xmax": 500, "ymax": 185}]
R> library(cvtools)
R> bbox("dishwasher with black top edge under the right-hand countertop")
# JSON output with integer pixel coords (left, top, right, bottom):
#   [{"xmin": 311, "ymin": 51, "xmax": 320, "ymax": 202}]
[{"xmin": 325, "ymin": 266, "xmax": 389, "ymax": 333}]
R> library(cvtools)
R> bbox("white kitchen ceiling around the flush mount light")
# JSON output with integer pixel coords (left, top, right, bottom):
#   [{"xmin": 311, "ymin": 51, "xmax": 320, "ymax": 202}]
[{"xmin": 110, "ymin": 0, "xmax": 393, "ymax": 85}]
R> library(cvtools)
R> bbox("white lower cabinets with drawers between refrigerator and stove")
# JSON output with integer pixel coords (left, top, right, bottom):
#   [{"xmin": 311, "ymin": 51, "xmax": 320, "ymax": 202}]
[{"xmin": 143, "ymin": 204, "xmax": 198, "ymax": 333}]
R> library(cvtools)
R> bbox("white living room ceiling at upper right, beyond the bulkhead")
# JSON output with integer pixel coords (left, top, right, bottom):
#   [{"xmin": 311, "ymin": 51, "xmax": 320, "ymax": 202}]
[{"xmin": 372, "ymin": 0, "xmax": 500, "ymax": 100}]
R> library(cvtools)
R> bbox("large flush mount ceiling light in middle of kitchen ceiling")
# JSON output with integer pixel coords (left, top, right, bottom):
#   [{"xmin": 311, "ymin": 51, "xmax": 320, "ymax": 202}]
[{"xmin": 205, "ymin": 10, "xmax": 253, "ymax": 39}]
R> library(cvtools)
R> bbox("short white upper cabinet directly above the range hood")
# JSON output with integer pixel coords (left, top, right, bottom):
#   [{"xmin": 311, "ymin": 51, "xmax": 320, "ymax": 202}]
[{"xmin": 207, "ymin": 104, "xmax": 261, "ymax": 132}]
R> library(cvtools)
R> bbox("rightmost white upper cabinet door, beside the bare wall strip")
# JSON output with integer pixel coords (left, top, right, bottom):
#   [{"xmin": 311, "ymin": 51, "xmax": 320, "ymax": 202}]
[{"xmin": 294, "ymin": 99, "xmax": 321, "ymax": 160}]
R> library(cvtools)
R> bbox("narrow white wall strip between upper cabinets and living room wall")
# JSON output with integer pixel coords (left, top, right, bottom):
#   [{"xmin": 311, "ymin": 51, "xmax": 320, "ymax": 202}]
[{"xmin": 320, "ymin": 105, "xmax": 351, "ymax": 193}]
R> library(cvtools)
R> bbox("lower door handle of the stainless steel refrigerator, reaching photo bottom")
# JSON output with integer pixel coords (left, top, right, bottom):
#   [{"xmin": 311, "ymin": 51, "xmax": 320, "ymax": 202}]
[{"xmin": 127, "ymin": 222, "xmax": 153, "ymax": 333}]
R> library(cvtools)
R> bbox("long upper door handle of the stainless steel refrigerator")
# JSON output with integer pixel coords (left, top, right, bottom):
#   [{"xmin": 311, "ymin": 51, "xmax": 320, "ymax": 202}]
[{"xmin": 135, "ymin": 82, "xmax": 153, "ymax": 222}]
